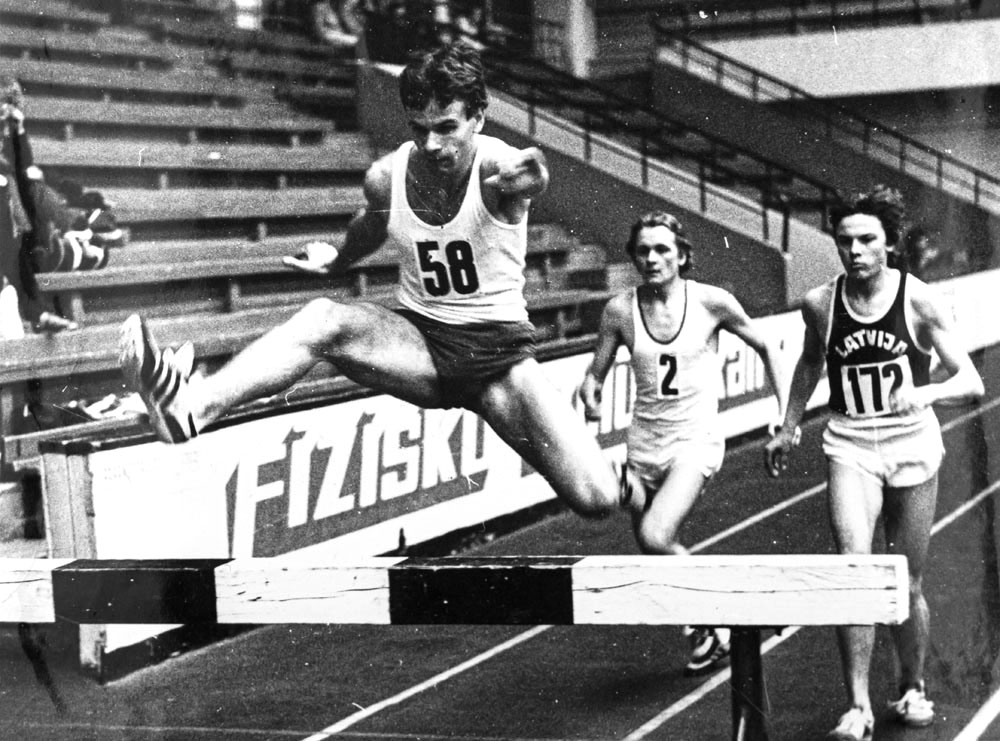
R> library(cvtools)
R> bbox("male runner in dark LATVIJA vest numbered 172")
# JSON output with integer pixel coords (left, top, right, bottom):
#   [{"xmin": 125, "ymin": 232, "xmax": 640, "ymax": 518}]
[{"xmin": 767, "ymin": 186, "xmax": 983, "ymax": 740}]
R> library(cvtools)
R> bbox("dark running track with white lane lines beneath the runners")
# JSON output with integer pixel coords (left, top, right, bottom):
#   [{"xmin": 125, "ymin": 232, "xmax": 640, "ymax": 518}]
[{"xmin": 0, "ymin": 349, "xmax": 1000, "ymax": 741}]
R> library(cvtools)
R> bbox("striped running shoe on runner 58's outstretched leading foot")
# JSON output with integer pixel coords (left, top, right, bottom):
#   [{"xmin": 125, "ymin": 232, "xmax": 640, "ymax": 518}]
[{"xmin": 119, "ymin": 314, "xmax": 198, "ymax": 443}]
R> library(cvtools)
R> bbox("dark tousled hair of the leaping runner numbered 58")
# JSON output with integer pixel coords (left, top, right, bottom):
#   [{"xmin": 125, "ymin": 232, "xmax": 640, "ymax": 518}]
[{"xmin": 399, "ymin": 41, "xmax": 487, "ymax": 118}]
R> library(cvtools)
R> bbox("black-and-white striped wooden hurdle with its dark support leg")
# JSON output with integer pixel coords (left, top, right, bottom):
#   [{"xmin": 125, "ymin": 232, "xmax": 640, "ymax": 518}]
[{"xmin": 0, "ymin": 554, "xmax": 909, "ymax": 741}]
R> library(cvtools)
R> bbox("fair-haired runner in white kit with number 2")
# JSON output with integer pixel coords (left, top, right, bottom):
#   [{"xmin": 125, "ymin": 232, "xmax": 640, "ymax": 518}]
[{"xmin": 579, "ymin": 211, "xmax": 785, "ymax": 675}]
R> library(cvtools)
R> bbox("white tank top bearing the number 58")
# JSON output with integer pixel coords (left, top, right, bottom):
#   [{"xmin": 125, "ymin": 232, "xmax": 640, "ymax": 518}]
[{"xmin": 386, "ymin": 135, "xmax": 528, "ymax": 324}]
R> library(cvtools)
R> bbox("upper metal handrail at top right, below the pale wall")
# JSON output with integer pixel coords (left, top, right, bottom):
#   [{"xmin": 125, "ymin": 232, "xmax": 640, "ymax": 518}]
[{"xmin": 652, "ymin": 20, "xmax": 1000, "ymax": 210}]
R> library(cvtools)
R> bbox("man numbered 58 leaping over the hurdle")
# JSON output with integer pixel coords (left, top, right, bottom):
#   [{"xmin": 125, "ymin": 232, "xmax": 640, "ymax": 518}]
[{"xmin": 121, "ymin": 43, "xmax": 618, "ymax": 516}]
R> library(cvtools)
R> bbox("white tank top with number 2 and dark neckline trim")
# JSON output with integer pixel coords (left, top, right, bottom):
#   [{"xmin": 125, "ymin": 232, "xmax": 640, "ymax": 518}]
[{"xmin": 632, "ymin": 280, "xmax": 722, "ymax": 433}]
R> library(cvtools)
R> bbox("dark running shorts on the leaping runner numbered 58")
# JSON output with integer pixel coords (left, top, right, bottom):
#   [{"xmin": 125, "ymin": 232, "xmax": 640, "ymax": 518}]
[{"xmin": 396, "ymin": 309, "xmax": 535, "ymax": 406}]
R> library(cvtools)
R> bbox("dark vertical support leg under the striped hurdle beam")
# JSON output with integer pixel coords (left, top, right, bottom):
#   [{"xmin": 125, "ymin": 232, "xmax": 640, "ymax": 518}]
[{"xmin": 729, "ymin": 626, "xmax": 770, "ymax": 741}]
